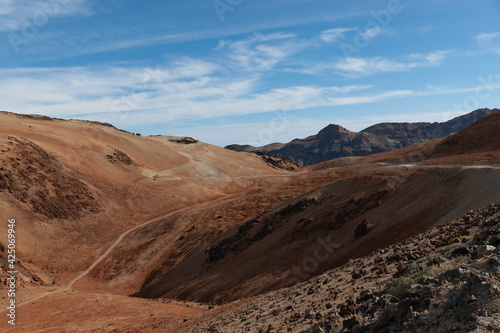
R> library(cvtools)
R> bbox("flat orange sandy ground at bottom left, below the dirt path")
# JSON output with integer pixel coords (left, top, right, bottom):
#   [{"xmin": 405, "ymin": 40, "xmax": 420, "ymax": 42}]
[{"xmin": 0, "ymin": 292, "xmax": 206, "ymax": 333}]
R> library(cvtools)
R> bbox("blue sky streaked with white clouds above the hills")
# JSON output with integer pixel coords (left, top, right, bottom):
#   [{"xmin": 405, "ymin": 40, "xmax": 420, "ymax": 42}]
[{"xmin": 0, "ymin": 0, "xmax": 500, "ymax": 146}]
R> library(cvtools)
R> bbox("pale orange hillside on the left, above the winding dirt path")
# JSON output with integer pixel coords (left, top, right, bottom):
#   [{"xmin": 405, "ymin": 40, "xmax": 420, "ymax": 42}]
[{"xmin": 0, "ymin": 112, "xmax": 295, "ymax": 294}]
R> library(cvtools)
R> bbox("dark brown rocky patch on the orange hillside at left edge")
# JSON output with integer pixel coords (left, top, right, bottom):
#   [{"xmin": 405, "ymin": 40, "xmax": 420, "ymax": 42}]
[{"xmin": 0, "ymin": 135, "xmax": 99, "ymax": 220}]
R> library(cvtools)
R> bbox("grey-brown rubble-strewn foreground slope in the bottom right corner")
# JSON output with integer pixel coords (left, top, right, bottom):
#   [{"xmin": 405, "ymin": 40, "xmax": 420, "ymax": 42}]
[{"xmin": 179, "ymin": 204, "xmax": 500, "ymax": 333}]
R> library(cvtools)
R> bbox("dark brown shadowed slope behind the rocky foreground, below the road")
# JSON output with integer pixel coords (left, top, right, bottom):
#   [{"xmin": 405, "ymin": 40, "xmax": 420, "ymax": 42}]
[{"xmin": 137, "ymin": 166, "xmax": 500, "ymax": 303}]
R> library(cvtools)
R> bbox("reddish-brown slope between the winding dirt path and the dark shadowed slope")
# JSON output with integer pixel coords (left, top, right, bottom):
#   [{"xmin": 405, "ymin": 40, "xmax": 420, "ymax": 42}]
[{"xmin": 81, "ymin": 165, "xmax": 339, "ymax": 294}]
